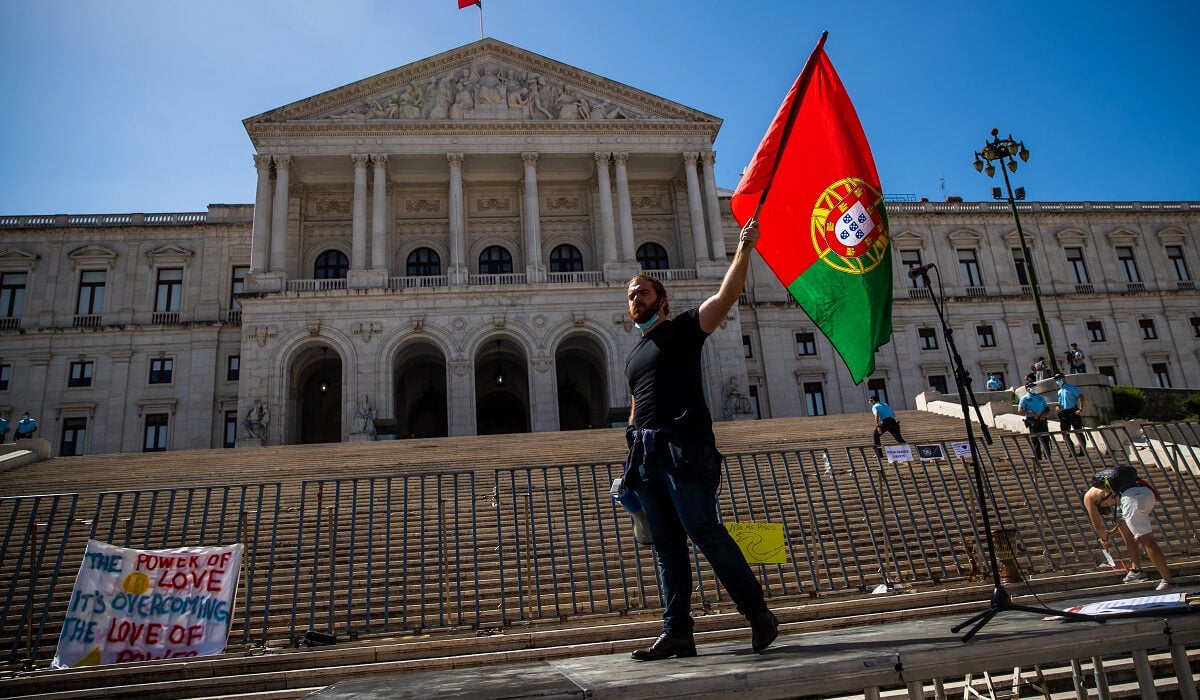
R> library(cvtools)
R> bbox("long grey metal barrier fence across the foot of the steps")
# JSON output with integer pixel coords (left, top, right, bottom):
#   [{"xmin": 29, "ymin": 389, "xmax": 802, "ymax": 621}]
[{"xmin": 0, "ymin": 424, "xmax": 1200, "ymax": 665}]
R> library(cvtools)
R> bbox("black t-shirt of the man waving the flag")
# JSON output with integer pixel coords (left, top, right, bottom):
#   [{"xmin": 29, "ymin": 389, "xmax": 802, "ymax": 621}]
[{"xmin": 625, "ymin": 309, "xmax": 712, "ymax": 427}]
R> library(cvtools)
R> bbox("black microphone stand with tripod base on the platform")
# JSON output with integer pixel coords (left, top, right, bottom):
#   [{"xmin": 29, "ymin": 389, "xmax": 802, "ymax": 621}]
[{"xmin": 908, "ymin": 264, "xmax": 1104, "ymax": 642}]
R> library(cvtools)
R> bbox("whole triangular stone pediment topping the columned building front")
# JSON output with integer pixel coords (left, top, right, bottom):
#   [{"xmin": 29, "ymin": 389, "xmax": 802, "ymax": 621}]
[{"xmin": 244, "ymin": 38, "xmax": 721, "ymax": 138}]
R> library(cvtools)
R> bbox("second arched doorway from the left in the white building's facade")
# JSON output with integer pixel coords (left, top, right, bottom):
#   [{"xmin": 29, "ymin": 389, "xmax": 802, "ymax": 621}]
[{"xmin": 393, "ymin": 342, "xmax": 450, "ymax": 438}]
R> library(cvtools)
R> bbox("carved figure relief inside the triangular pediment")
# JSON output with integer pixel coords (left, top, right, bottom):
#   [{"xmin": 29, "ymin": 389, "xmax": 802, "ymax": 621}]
[{"xmin": 318, "ymin": 60, "xmax": 654, "ymax": 121}]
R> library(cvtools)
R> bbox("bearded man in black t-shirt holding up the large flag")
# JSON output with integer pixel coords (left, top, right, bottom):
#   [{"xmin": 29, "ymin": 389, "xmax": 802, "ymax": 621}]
[{"xmin": 624, "ymin": 219, "xmax": 779, "ymax": 662}]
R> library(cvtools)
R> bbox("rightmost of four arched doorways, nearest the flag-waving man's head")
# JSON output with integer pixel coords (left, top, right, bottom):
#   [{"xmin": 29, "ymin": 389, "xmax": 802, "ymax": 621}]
[{"xmin": 554, "ymin": 334, "xmax": 608, "ymax": 430}]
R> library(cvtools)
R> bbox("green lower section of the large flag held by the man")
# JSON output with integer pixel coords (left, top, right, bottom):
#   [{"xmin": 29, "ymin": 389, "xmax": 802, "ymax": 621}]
[{"xmin": 787, "ymin": 246, "xmax": 892, "ymax": 384}]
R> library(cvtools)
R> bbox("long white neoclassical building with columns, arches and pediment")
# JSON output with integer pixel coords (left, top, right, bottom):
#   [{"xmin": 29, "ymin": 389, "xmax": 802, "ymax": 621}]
[{"xmin": 0, "ymin": 38, "xmax": 1200, "ymax": 454}]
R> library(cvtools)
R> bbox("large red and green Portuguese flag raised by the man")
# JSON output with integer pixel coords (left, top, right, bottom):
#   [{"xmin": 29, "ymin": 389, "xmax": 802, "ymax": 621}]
[{"xmin": 732, "ymin": 32, "xmax": 892, "ymax": 384}]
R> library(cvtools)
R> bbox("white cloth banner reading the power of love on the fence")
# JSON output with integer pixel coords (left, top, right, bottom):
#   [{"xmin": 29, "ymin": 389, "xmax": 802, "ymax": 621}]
[{"xmin": 52, "ymin": 539, "xmax": 242, "ymax": 669}]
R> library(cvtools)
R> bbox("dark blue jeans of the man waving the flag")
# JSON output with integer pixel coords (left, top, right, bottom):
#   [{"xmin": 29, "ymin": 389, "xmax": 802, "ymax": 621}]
[{"xmin": 635, "ymin": 453, "xmax": 767, "ymax": 634}]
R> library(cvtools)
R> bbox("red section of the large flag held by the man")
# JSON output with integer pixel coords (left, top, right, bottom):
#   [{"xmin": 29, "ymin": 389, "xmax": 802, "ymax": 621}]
[{"xmin": 731, "ymin": 35, "xmax": 880, "ymax": 285}]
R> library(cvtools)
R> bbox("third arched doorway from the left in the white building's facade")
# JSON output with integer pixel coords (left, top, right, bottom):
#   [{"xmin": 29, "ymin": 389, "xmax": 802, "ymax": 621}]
[{"xmin": 475, "ymin": 339, "xmax": 529, "ymax": 435}]
